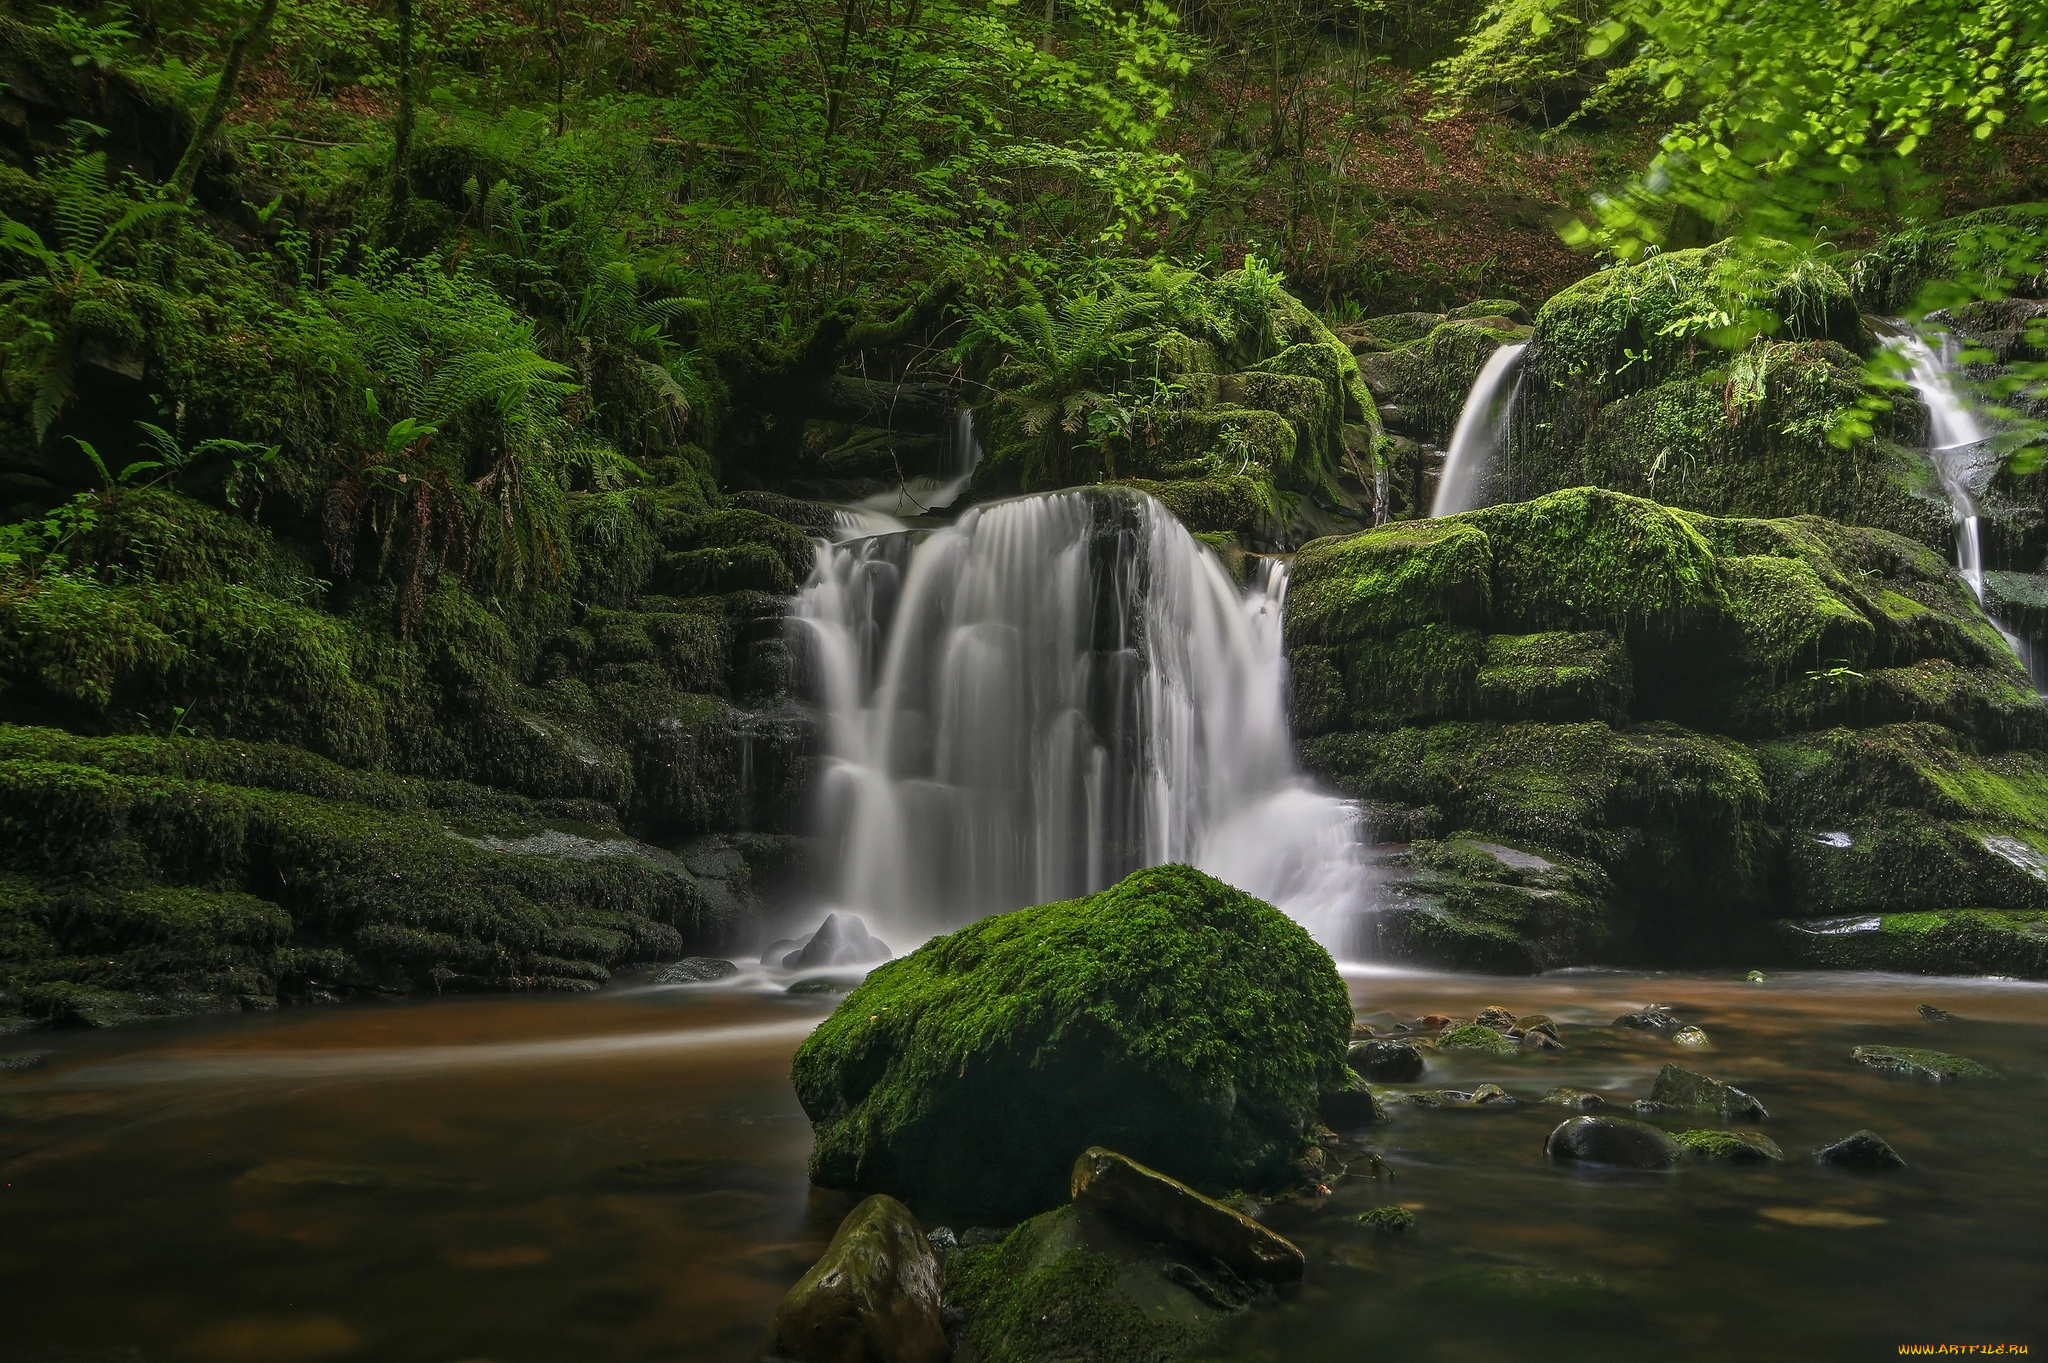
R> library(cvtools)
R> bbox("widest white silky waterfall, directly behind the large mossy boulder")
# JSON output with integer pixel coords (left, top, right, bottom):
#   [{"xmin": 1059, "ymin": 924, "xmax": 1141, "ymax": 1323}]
[{"xmin": 793, "ymin": 489, "xmax": 1366, "ymax": 956}]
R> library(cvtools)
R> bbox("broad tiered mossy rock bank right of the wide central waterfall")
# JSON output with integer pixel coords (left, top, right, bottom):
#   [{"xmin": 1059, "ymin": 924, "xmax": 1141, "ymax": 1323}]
[{"xmin": 1288, "ymin": 489, "xmax": 2048, "ymax": 968}]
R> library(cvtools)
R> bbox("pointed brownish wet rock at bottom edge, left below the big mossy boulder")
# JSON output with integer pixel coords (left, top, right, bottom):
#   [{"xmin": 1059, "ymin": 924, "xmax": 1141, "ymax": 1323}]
[{"xmin": 768, "ymin": 1193, "xmax": 952, "ymax": 1363}]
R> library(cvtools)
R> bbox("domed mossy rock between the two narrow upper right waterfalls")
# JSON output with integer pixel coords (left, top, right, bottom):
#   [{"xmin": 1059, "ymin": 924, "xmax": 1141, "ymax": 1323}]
[{"xmin": 1505, "ymin": 248, "xmax": 1954, "ymax": 551}]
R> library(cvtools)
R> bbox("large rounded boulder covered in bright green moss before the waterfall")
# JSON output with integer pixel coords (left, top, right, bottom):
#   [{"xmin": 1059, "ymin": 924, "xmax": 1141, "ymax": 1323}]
[{"xmin": 791, "ymin": 866, "xmax": 1352, "ymax": 1224}]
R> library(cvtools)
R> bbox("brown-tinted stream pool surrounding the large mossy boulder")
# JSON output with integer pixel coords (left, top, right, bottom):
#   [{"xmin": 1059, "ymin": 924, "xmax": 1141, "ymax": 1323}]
[{"xmin": 0, "ymin": 972, "xmax": 2048, "ymax": 1363}]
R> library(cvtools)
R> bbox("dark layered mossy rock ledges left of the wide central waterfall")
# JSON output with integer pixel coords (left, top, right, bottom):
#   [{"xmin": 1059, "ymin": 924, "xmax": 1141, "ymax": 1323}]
[{"xmin": 0, "ymin": 481, "xmax": 815, "ymax": 1021}]
